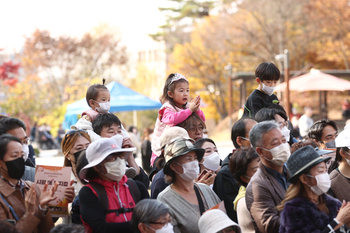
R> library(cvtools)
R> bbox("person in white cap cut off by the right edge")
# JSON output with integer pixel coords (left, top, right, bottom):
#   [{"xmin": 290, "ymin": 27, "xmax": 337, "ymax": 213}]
[{"xmin": 328, "ymin": 130, "xmax": 350, "ymax": 202}]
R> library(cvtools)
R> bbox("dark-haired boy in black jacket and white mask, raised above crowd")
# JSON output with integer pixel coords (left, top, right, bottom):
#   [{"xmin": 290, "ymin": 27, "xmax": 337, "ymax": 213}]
[{"xmin": 243, "ymin": 62, "xmax": 280, "ymax": 118}]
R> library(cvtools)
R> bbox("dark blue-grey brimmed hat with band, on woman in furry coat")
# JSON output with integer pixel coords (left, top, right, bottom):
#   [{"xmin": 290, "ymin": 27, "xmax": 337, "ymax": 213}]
[{"xmin": 287, "ymin": 146, "xmax": 332, "ymax": 183}]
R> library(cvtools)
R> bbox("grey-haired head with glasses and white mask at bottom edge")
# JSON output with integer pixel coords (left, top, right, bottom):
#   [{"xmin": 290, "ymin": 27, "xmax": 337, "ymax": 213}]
[{"xmin": 131, "ymin": 199, "xmax": 174, "ymax": 233}]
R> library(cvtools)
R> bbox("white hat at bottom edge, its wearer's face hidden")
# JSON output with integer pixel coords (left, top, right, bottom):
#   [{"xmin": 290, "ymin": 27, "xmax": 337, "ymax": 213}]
[{"xmin": 198, "ymin": 209, "xmax": 241, "ymax": 233}]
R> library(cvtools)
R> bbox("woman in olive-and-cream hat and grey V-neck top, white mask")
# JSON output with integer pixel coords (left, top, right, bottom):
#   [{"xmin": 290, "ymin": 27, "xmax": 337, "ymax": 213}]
[{"xmin": 157, "ymin": 138, "xmax": 220, "ymax": 233}]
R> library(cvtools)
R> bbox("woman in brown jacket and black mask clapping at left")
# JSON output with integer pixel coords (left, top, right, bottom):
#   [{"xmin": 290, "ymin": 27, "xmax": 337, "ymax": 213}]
[{"xmin": 0, "ymin": 134, "xmax": 58, "ymax": 233}]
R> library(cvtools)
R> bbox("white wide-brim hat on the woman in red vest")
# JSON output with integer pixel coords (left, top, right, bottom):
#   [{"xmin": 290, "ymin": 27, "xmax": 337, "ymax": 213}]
[{"xmin": 79, "ymin": 135, "xmax": 136, "ymax": 179}]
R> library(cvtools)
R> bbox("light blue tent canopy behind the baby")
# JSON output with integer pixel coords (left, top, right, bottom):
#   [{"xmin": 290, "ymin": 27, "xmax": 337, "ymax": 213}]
[{"xmin": 64, "ymin": 81, "xmax": 162, "ymax": 128}]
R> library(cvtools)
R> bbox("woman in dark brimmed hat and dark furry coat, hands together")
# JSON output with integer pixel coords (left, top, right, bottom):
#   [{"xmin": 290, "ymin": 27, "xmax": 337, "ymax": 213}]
[{"xmin": 276, "ymin": 146, "xmax": 350, "ymax": 233}]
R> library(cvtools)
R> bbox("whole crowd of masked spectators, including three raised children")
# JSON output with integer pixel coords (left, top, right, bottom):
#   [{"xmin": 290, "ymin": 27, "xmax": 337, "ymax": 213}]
[{"xmin": 0, "ymin": 63, "xmax": 350, "ymax": 233}]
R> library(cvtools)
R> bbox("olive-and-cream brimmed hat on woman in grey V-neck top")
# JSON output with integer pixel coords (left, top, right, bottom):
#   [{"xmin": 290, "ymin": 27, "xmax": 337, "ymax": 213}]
[{"xmin": 163, "ymin": 138, "xmax": 205, "ymax": 175}]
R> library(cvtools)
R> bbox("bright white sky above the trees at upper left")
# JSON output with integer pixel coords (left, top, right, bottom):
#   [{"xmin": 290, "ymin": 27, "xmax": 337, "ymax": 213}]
[{"xmin": 0, "ymin": 0, "xmax": 168, "ymax": 53}]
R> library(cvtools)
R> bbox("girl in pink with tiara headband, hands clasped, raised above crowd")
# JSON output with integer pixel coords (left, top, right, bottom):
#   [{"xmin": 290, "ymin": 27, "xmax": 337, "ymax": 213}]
[{"xmin": 151, "ymin": 73, "xmax": 205, "ymax": 165}]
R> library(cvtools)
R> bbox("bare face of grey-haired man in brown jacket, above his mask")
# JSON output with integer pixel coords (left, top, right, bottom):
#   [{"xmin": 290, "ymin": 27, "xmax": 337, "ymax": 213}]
[{"xmin": 257, "ymin": 129, "xmax": 287, "ymax": 160}]
